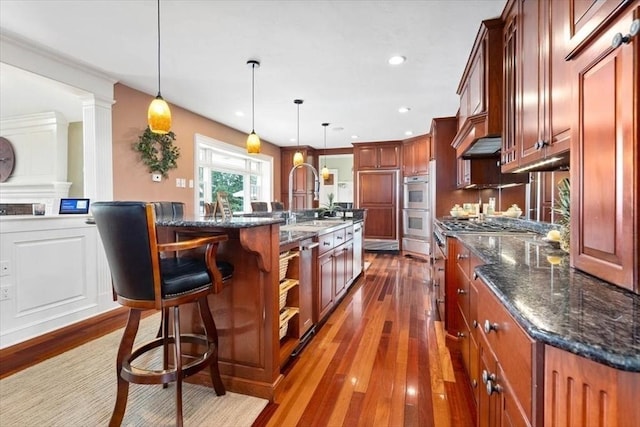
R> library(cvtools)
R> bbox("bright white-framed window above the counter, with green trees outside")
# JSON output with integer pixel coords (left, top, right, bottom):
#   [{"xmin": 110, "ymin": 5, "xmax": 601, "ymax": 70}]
[{"xmin": 195, "ymin": 134, "xmax": 273, "ymax": 214}]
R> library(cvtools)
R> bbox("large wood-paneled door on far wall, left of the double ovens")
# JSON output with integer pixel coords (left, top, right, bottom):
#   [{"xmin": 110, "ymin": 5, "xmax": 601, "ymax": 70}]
[{"xmin": 358, "ymin": 170, "xmax": 398, "ymax": 240}]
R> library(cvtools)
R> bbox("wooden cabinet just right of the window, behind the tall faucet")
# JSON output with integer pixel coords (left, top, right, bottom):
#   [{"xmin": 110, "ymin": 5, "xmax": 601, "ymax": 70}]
[{"xmin": 280, "ymin": 146, "xmax": 315, "ymax": 211}]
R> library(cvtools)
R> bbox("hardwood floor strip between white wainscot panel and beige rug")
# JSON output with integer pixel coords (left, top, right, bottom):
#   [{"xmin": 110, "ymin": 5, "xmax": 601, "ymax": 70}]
[{"xmin": 0, "ymin": 307, "xmax": 155, "ymax": 379}]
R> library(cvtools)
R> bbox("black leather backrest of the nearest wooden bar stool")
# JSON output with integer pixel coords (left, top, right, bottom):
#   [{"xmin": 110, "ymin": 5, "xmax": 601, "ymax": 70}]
[{"xmin": 91, "ymin": 202, "xmax": 161, "ymax": 307}]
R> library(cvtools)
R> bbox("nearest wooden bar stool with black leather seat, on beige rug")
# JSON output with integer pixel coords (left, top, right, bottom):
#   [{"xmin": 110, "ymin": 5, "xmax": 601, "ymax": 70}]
[{"xmin": 92, "ymin": 202, "xmax": 227, "ymax": 426}]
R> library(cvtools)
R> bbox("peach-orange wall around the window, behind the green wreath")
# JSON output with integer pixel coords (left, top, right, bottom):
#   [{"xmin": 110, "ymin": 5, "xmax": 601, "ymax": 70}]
[{"xmin": 112, "ymin": 83, "xmax": 280, "ymax": 212}]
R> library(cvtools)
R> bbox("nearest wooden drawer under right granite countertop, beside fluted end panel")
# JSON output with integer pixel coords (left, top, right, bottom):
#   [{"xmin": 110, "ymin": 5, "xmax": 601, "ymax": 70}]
[{"xmin": 478, "ymin": 281, "xmax": 534, "ymax": 419}]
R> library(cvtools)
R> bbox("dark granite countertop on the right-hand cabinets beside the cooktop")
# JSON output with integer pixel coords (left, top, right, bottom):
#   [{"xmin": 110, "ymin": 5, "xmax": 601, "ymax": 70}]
[{"xmin": 456, "ymin": 234, "xmax": 640, "ymax": 372}]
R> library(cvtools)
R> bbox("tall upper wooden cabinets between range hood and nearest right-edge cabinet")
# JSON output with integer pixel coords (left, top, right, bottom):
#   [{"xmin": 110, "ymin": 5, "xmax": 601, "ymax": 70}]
[{"xmin": 501, "ymin": 0, "xmax": 571, "ymax": 172}]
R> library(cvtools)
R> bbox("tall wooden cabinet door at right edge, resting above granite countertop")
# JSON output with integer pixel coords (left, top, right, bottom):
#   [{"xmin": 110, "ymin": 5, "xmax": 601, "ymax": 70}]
[{"xmin": 571, "ymin": 1, "xmax": 640, "ymax": 293}]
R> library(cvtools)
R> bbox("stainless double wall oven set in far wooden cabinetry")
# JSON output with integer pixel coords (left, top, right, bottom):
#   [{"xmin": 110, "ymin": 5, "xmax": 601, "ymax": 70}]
[{"xmin": 402, "ymin": 175, "xmax": 432, "ymax": 258}]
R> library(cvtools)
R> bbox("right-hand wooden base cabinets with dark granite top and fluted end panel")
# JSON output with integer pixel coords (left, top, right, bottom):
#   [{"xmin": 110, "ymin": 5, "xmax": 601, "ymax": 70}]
[{"xmin": 447, "ymin": 233, "xmax": 640, "ymax": 426}]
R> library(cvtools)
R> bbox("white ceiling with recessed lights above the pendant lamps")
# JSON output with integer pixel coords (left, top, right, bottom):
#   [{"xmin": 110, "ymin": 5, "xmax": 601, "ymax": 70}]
[{"xmin": 0, "ymin": 0, "xmax": 505, "ymax": 148}]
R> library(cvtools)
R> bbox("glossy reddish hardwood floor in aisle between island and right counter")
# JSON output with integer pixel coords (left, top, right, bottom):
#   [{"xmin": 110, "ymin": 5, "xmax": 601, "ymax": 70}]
[{"xmin": 254, "ymin": 253, "xmax": 475, "ymax": 427}]
